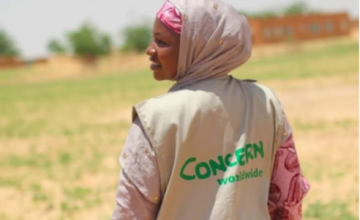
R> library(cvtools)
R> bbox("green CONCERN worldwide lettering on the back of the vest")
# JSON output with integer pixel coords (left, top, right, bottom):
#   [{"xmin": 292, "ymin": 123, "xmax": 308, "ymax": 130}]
[{"xmin": 180, "ymin": 141, "xmax": 264, "ymax": 185}]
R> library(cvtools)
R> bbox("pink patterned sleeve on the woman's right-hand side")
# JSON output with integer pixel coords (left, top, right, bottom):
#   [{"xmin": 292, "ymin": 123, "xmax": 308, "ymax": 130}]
[{"xmin": 268, "ymin": 116, "xmax": 310, "ymax": 220}]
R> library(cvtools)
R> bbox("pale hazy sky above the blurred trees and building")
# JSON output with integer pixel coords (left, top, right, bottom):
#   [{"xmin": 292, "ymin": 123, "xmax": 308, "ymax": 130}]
[{"xmin": 0, "ymin": 0, "xmax": 360, "ymax": 58}]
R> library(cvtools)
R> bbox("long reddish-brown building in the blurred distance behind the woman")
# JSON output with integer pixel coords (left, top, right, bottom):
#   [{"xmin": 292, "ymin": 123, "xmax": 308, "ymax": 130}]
[{"xmin": 249, "ymin": 13, "xmax": 351, "ymax": 45}]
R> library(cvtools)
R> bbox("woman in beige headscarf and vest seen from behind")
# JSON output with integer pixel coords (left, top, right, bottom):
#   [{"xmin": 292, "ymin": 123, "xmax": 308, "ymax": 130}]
[{"xmin": 112, "ymin": 0, "xmax": 309, "ymax": 220}]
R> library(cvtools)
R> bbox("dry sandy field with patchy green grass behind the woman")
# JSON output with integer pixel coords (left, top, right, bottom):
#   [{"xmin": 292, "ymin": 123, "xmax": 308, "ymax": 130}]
[{"xmin": 0, "ymin": 38, "xmax": 360, "ymax": 220}]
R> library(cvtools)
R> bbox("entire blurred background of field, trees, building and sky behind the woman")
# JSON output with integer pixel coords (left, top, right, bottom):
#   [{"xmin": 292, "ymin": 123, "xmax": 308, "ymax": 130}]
[{"xmin": 0, "ymin": 0, "xmax": 360, "ymax": 220}]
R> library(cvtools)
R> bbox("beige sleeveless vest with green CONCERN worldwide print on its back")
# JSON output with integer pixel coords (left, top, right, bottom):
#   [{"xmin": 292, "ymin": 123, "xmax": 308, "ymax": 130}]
[{"xmin": 134, "ymin": 76, "xmax": 283, "ymax": 220}]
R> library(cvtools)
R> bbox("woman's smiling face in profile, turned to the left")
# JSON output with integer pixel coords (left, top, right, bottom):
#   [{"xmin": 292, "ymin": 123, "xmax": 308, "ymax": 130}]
[{"xmin": 146, "ymin": 19, "xmax": 180, "ymax": 81}]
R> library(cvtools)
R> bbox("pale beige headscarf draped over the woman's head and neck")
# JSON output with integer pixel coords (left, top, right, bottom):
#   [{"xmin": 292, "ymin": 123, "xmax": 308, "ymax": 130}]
[{"xmin": 158, "ymin": 0, "xmax": 252, "ymax": 91}]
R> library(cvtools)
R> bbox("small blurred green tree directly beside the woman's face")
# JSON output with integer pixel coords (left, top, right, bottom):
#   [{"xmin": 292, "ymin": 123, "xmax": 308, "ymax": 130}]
[{"xmin": 122, "ymin": 24, "xmax": 151, "ymax": 52}]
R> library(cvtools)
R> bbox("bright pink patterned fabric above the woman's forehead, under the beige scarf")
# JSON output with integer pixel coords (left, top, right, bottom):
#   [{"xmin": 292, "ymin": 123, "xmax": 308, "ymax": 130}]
[{"xmin": 156, "ymin": 1, "xmax": 182, "ymax": 34}]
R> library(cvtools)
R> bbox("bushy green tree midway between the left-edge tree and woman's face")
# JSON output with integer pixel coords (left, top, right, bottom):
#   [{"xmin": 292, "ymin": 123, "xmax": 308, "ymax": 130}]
[{"xmin": 67, "ymin": 23, "xmax": 112, "ymax": 59}]
